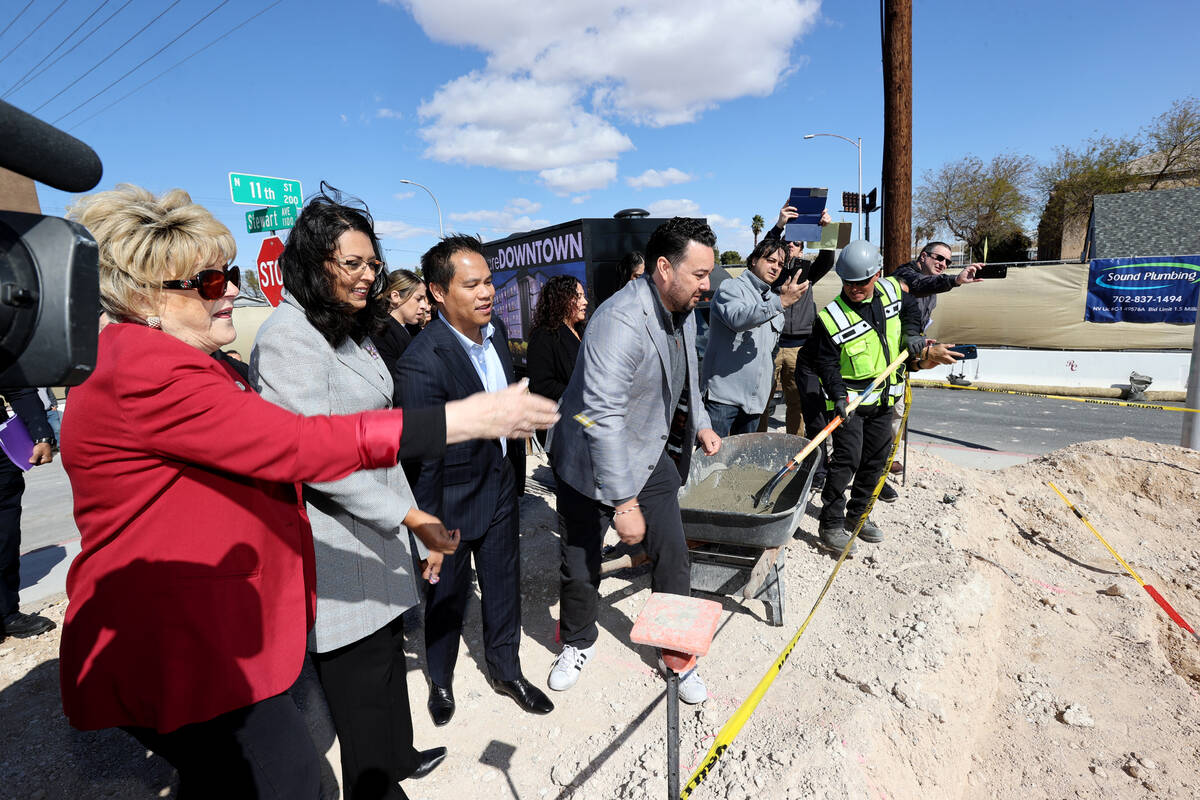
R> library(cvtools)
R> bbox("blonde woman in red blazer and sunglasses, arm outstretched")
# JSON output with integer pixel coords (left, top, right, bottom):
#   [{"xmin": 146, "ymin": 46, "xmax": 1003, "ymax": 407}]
[{"xmin": 60, "ymin": 185, "xmax": 553, "ymax": 798}]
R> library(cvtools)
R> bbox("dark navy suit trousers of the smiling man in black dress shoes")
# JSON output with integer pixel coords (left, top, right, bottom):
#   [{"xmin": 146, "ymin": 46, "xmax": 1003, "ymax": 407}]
[{"xmin": 425, "ymin": 458, "xmax": 521, "ymax": 687}]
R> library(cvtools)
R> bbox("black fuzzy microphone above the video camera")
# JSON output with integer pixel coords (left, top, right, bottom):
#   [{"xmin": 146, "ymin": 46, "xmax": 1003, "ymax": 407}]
[{"xmin": 0, "ymin": 100, "xmax": 104, "ymax": 192}]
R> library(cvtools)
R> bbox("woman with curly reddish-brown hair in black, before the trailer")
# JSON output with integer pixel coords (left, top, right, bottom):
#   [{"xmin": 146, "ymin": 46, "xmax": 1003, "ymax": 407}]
[{"xmin": 526, "ymin": 275, "xmax": 588, "ymax": 401}]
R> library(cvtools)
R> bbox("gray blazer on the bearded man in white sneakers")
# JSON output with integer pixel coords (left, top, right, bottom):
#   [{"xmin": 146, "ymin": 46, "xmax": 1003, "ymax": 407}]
[{"xmin": 547, "ymin": 278, "xmax": 712, "ymax": 504}]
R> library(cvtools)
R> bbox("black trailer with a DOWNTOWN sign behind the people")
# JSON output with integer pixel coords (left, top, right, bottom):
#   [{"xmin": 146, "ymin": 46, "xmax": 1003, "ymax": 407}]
[{"xmin": 484, "ymin": 210, "xmax": 725, "ymax": 368}]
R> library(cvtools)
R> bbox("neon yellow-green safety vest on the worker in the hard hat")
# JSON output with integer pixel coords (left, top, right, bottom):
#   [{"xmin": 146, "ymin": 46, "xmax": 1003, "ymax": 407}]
[{"xmin": 817, "ymin": 278, "xmax": 904, "ymax": 409}]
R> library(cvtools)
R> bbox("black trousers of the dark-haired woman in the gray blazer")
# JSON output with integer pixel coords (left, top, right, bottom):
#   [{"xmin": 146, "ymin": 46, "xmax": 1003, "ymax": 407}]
[{"xmin": 310, "ymin": 616, "xmax": 420, "ymax": 800}]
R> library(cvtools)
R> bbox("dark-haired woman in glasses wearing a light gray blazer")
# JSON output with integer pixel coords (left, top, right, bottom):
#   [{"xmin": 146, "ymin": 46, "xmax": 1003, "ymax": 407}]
[{"xmin": 251, "ymin": 184, "xmax": 547, "ymax": 800}]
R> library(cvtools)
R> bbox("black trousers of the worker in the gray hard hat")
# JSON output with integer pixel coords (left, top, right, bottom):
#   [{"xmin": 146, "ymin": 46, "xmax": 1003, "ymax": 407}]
[{"xmin": 821, "ymin": 405, "xmax": 892, "ymax": 528}]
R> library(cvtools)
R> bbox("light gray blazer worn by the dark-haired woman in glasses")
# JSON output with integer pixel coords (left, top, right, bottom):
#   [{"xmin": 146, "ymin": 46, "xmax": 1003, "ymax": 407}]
[{"xmin": 250, "ymin": 293, "xmax": 426, "ymax": 652}]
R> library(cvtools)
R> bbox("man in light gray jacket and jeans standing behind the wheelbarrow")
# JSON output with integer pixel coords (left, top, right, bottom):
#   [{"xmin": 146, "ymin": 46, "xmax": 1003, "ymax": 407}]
[{"xmin": 700, "ymin": 239, "xmax": 809, "ymax": 437}]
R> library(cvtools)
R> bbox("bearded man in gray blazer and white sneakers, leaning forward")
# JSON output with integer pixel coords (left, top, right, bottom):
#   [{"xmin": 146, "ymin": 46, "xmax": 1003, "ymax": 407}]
[{"xmin": 548, "ymin": 217, "xmax": 721, "ymax": 703}]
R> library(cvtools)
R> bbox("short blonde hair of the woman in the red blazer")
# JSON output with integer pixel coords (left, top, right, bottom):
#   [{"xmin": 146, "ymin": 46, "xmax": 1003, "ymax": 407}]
[{"xmin": 67, "ymin": 184, "xmax": 238, "ymax": 319}]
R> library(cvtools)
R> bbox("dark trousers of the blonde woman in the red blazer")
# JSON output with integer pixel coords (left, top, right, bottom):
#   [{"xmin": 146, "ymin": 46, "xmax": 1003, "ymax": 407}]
[{"xmin": 125, "ymin": 693, "xmax": 320, "ymax": 800}]
